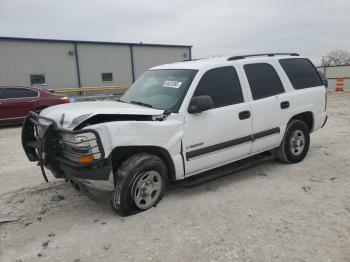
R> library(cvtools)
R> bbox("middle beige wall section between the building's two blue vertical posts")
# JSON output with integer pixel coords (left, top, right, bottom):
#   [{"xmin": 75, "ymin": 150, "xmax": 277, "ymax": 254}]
[{"xmin": 78, "ymin": 44, "xmax": 132, "ymax": 86}]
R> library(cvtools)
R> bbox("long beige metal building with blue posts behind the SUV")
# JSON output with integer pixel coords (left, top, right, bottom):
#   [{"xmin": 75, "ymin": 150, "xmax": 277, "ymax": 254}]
[{"xmin": 0, "ymin": 37, "xmax": 192, "ymax": 89}]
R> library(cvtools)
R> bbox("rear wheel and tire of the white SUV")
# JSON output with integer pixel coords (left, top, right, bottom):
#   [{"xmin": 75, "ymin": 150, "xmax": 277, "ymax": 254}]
[{"xmin": 276, "ymin": 120, "xmax": 310, "ymax": 164}]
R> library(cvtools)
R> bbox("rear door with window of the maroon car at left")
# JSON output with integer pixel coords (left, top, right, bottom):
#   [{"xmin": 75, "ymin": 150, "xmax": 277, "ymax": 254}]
[{"xmin": 1, "ymin": 87, "xmax": 38, "ymax": 120}]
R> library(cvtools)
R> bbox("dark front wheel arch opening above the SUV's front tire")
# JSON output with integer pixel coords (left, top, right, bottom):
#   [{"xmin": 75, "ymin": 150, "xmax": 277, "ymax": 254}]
[{"xmin": 110, "ymin": 146, "xmax": 176, "ymax": 181}]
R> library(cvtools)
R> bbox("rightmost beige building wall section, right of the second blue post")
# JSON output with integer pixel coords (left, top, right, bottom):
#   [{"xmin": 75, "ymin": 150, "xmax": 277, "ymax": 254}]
[{"xmin": 133, "ymin": 46, "xmax": 190, "ymax": 78}]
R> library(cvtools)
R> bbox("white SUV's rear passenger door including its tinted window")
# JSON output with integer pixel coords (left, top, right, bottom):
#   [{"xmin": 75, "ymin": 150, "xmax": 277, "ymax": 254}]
[{"xmin": 243, "ymin": 62, "xmax": 294, "ymax": 154}]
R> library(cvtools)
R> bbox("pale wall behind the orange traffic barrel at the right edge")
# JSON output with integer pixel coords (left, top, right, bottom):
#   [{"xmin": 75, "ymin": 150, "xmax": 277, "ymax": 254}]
[{"xmin": 317, "ymin": 65, "xmax": 350, "ymax": 91}]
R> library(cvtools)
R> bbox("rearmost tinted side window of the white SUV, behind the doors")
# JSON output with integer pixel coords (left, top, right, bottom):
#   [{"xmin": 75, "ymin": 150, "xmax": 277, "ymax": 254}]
[{"xmin": 280, "ymin": 58, "xmax": 323, "ymax": 89}]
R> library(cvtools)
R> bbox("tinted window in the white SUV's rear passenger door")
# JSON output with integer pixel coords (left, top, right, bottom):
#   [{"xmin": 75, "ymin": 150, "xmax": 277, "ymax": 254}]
[{"xmin": 244, "ymin": 63, "xmax": 284, "ymax": 100}]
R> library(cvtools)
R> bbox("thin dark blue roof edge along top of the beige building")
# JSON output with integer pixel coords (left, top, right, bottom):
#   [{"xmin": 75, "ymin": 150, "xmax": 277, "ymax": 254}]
[{"xmin": 0, "ymin": 36, "xmax": 192, "ymax": 48}]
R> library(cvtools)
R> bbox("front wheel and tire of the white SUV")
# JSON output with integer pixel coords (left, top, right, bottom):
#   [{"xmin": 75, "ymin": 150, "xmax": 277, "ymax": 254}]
[{"xmin": 111, "ymin": 153, "xmax": 167, "ymax": 216}]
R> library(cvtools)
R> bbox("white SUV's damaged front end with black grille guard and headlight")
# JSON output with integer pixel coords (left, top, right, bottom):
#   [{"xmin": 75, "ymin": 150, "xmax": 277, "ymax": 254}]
[{"xmin": 22, "ymin": 112, "xmax": 114, "ymax": 188}]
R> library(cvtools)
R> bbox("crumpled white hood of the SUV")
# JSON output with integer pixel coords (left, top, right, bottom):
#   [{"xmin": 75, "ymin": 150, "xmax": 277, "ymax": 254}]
[{"xmin": 40, "ymin": 101, "xmax": 164, "ymax": 129}]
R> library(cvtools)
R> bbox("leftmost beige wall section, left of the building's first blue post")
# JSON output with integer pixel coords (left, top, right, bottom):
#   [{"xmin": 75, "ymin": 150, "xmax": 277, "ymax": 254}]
[{"xmin": 0, "ymin": 40, "xmax": 77, "ymax": 88}]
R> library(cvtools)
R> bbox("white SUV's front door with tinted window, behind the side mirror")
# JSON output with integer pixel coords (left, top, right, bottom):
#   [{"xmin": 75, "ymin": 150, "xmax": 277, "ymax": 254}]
[{"xmin": 183, "ymin": 66, "xmax": 252, "ymax": 176}]
